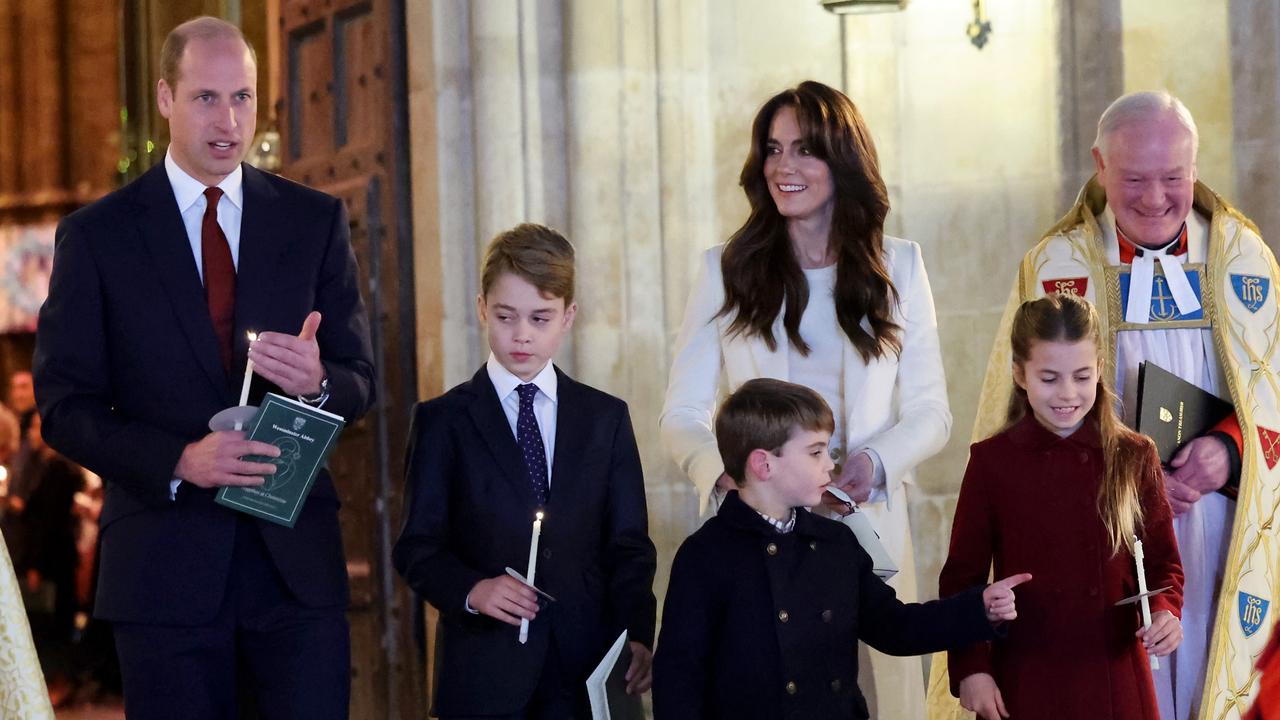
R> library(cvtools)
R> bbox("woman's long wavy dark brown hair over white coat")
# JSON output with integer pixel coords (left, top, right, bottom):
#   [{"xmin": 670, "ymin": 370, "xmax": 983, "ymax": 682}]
[{"xmin": 717, "ymin": 81, "xmax": 902, "ymax": 361}]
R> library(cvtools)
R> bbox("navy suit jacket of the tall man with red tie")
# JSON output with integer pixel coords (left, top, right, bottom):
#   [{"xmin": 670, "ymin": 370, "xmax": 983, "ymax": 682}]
[{"xmin": 33, "ymin": 164, "xmax": 374, "ymax": 625}]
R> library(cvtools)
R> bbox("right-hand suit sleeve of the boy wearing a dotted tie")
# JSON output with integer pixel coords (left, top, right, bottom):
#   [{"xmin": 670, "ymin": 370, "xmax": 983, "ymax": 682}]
[{"xmin": 604, "ymin": 404, "xmax": 658, "ymax": 648}]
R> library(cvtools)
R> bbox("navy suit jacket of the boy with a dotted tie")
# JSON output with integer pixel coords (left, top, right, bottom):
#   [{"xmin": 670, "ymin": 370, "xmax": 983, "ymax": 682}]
[{"xmin": 392, "ymin": 368, "xmax": 657, "ymax": 716}]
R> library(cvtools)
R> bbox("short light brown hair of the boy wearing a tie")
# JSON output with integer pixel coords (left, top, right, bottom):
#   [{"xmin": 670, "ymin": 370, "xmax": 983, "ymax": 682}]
[{"xmin": 480, "ymin": 223, "xmax": 573, "ymax": 306}]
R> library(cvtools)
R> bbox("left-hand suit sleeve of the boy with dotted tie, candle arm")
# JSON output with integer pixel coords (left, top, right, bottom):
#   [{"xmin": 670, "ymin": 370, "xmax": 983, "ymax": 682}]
[{"xmin": 392, "ymin": 401, "xmax": 485, "ymax": 614}]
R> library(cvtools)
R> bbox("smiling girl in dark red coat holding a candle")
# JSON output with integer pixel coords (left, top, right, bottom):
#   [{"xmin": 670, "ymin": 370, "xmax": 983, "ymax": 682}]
[{"xmin": 938, "ymin": 295, "xmax": 1183, "ymax": 720}]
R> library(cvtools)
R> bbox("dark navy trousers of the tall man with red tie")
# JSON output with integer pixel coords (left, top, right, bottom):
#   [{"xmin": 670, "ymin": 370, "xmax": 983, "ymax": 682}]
[{"xmin": 114, "ymin": 518, "xmax": 351, "ymax": 720}]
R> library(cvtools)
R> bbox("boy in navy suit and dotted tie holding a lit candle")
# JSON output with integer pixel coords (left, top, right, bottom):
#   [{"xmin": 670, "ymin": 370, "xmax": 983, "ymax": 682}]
[{"xmin": 393, "ymin": 224, "xmax": 657, "ymax": 720}]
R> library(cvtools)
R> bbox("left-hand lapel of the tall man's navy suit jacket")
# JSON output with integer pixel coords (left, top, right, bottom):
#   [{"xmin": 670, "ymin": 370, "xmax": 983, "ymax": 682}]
[{"xmin": 138, "ymin": 164, "xmax": 230, "ymax": 405}]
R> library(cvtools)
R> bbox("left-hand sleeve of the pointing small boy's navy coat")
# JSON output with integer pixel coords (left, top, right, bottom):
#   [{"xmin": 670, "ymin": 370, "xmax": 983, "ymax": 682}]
[{"xmin": 653, "ymin": 541, "xmax": 724, "ymax": 720}]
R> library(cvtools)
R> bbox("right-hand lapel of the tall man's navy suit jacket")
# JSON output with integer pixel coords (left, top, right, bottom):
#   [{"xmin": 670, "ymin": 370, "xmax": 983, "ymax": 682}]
[{"xmin": 232, "ymin": 165, "xmax": 290, "ymax": 377}]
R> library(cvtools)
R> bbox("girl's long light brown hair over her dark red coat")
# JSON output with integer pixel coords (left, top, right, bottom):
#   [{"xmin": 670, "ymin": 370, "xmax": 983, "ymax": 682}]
[{"xmin": 1009, "ymin": 293, "xmax": 1151, "ymax": 553}]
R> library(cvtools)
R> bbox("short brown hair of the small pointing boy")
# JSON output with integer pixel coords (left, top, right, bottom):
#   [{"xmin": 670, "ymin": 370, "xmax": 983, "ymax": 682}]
[{"xmin": 716, "ymin": 378, "xmax": 836, "ymax": 487}]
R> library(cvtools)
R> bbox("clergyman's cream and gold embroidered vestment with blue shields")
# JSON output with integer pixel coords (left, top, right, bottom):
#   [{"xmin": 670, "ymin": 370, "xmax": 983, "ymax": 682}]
[{"xmin": 929, "ymin": 179, "xmax": 1280, "ymax": 720}]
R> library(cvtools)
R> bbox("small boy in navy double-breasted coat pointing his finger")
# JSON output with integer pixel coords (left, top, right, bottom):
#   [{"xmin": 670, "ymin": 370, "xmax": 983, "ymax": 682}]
[{"xmin": 654, "ymin": 379, "xmax": 1030, "ymax": 720}]
